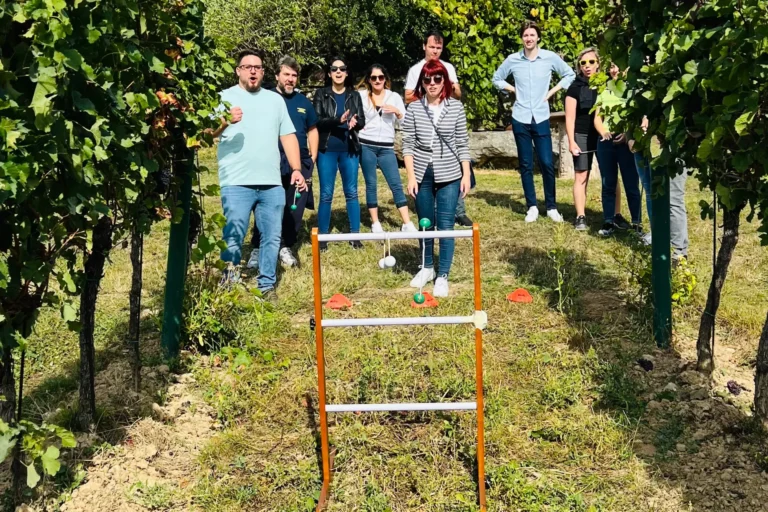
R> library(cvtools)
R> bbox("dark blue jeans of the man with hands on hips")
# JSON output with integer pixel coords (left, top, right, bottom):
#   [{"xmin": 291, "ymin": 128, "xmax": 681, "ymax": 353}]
[{"xmin": 512, "ymin": 119, "xmax": 557, "ymax": 210}]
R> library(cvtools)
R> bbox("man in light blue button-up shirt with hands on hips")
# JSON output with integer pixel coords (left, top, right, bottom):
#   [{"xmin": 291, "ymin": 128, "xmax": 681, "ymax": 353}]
[{"xmin": 493, "ymin": 21, "xmax": 576, "ymax": 222}]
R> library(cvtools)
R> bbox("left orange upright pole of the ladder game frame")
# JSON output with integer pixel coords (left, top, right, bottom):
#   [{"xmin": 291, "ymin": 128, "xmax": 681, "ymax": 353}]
[{"xmin": 312, "ymin": 228, "xmax": 331, "ymax": 512}]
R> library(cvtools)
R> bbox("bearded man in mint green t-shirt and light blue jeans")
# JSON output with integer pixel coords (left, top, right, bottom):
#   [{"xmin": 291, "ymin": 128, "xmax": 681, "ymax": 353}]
[{"xmin": 213, "ymin": 50, "xmax": 307, "ymax": 300}]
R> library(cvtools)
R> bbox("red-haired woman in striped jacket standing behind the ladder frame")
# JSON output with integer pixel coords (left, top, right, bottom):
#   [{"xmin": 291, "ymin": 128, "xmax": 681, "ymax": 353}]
[{"xmin": 403, "ymin": 60, "xmax": 471, "ymax": 297}]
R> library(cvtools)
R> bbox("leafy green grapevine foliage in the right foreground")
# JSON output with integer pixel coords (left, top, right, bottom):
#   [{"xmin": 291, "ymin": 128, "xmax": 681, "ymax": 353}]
[{"xmin": 597, "ymin": 0, "xmax": 768, "ymax": 244}]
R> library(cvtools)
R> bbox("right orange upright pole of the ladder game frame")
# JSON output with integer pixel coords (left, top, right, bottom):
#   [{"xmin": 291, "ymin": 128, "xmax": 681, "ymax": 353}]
[{"xmin": 472, "ymin": 224, "xmax": 486, "ymax": 512}]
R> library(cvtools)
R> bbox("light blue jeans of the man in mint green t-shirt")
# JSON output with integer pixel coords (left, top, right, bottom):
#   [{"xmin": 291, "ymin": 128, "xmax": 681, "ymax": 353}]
[{"xmin": 221, "ymin": 185, "xmax": 285, "ymax": 292}]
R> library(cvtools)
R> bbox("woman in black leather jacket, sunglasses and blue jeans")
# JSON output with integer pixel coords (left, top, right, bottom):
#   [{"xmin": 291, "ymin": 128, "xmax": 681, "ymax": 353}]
[{"xmin": 314, "ymin": 57, "xmax": 365, "ymax": 250}]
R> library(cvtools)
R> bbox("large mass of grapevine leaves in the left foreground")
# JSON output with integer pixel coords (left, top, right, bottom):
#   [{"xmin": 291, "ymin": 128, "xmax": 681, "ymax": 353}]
[{"xmin": 0, "ymin": 0, "xmax": 232, "ymax": 358}]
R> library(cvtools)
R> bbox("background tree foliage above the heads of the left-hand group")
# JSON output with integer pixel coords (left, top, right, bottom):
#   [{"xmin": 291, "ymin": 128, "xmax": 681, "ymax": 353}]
[{"xmin": 205, "ymin": 0, "xmax": 434, "ymax": 78}]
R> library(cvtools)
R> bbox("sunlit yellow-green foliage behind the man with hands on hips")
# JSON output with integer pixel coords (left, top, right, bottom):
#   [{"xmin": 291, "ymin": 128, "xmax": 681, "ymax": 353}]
[{"xmin": 426, "ymin": 0, "xmax": 598, "ymax": 128}]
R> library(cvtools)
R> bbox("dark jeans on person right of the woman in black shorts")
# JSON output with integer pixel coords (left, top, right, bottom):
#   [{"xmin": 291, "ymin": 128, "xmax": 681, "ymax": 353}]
[{"xmin": 597, "ymin": 140, "xmax": 643, "ymax": 224}]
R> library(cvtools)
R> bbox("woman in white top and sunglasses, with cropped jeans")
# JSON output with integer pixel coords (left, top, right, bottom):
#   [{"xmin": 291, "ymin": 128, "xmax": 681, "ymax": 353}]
[{"xmin": 358, "ymin": 64, "xmax": 418, "ymax": 233}]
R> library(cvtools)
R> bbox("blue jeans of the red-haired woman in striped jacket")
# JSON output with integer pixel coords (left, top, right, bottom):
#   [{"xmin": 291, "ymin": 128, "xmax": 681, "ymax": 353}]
[{"xmin": 416, "ymin": 164, "xmax": 461, "ymax": 277}]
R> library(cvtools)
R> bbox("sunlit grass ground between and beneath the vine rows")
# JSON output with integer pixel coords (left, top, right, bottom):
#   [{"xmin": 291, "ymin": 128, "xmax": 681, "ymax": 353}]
[{"xmin": 16, "ymin": 146, "xmax": 768, "ymax": 512}]
